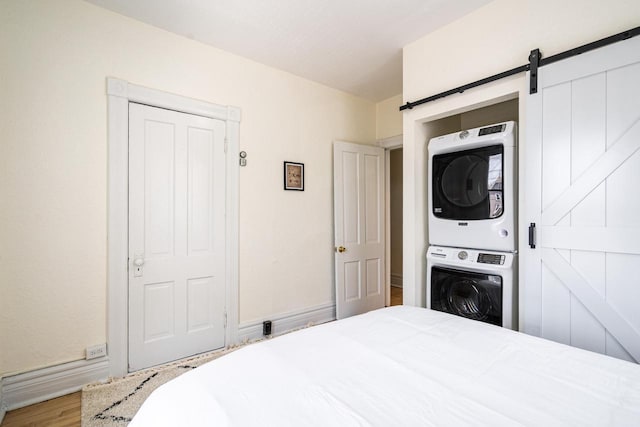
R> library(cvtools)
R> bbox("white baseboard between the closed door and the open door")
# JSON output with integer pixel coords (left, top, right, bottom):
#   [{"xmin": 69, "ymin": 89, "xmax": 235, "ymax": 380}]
[{"xmin": 238, "ymin": 303, "xmax": 336, "ymax": 343}]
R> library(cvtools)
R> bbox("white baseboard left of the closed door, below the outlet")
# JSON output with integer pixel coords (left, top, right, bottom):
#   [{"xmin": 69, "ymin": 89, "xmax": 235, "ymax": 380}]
[{"xmin": 0, "ymin": 357, "xmax": 109, "ymax": 411}]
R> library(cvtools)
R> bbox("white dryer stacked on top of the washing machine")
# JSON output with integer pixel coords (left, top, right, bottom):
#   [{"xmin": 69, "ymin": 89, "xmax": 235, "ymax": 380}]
[{"xmin": 428, "ymin": 122, "xmax": 517, "ymax": 252}]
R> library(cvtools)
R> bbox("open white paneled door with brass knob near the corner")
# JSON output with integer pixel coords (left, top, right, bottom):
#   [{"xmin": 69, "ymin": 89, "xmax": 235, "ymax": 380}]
[{"xmin": 333, "ymin": 142, "xmax": 385, "ymax": 319}]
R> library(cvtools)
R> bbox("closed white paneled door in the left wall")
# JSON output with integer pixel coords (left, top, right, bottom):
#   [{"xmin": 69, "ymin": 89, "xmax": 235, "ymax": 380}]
[{"xmin": 129, "ymin": 103, "xmax": 225, "ymax": 371}]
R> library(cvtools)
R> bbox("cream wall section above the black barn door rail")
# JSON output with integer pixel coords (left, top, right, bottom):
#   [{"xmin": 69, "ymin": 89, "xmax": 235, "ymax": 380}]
[{"xmin": 403, "ymin": 0, "xmax": 640, "ymax": 102}]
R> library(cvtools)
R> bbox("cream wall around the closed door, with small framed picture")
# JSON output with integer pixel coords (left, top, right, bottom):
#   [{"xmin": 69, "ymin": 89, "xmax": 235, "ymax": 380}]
[{"xmin": 0, "ymin": 0, "xmax": 376, "ymax": 375}]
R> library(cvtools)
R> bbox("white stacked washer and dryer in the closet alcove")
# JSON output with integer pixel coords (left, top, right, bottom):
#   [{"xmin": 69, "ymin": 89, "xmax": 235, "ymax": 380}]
[{"xmin": 426, "ymin": 122, "xmax": 518, "ymax": 330}]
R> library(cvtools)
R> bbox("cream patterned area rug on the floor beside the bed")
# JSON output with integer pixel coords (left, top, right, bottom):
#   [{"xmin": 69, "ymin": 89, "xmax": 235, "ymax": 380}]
[{"xmin": 82, "ymin": 347, "xmax": 245, "ymax": 427}]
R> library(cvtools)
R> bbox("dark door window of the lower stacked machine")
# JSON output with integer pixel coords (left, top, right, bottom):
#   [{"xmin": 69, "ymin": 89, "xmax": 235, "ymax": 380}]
[{"xmin": 431, "ymin": 267, "xmax": 502, "ymax": 326}]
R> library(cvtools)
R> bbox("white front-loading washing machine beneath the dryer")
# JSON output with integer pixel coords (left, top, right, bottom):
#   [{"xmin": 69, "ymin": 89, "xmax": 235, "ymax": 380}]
[{"xmin": 427, "ymin": 246, "xmax": 518, "ymax": 330}]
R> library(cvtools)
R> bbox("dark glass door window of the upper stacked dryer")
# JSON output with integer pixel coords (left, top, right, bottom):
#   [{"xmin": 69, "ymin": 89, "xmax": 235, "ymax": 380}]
[{"xmin": 432, "ymin": 144, "xmax": 504, "ymax": 220}]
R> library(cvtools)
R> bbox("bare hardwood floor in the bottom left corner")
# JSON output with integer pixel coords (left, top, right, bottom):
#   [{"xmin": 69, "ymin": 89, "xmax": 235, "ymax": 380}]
[{"xmin": 0, "ymin": 392, "xmax": 81, "ymax": 427}]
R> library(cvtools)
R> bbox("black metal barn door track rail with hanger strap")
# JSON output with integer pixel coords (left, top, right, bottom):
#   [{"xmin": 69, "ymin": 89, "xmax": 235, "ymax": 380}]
[{"xmin": 400, "ymin": 27, "xmax": 640, "ymax": 111}]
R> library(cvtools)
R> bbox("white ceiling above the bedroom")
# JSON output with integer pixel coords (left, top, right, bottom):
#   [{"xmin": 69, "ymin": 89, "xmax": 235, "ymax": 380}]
[{"xmin": 86, "ymin": 0, "xmax": 490, "ymax": 101}]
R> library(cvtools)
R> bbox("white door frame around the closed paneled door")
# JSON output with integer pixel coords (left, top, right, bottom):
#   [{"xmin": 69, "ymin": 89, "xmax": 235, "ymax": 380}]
[{"xmin": 107, "ymin": 77, "xmax": 240, "ymax": 377}]
